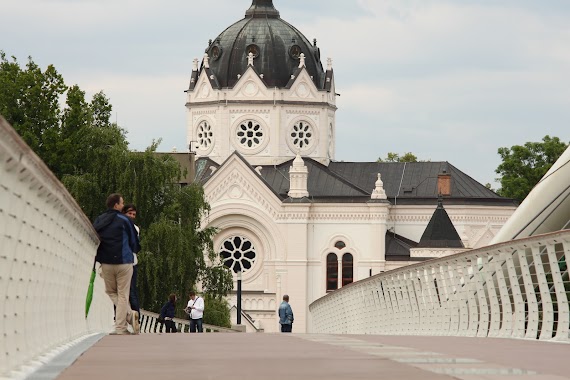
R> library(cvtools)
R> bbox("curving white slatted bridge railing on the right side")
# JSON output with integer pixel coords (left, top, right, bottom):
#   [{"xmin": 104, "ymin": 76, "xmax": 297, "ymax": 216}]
[{"xmin": 309, "ymin": 230, "xmax": 570, "ymax": 342}]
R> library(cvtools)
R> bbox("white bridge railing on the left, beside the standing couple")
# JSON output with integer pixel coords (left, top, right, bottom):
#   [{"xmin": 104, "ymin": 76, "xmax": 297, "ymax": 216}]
[{"xmin": 0, "ymin": 117, "xmax": 113, "ymax": 378}]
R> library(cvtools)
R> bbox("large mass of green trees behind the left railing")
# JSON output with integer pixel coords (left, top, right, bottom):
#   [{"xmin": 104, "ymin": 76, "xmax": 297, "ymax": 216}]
[{"xmin": 0, "ymin": 51, "xmax": 233, "ymax": 323}]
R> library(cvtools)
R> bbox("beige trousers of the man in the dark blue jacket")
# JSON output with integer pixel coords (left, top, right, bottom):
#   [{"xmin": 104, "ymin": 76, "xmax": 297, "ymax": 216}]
[{"xmin": 101, "ymin": 264, "xmax": 133, "ymax": 332}]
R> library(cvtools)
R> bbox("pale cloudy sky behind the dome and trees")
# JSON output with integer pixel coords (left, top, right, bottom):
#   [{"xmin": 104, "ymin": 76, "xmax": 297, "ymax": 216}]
[{"xmin": 0, "ymin": 0, "xmax": 570, "ymax": 188}]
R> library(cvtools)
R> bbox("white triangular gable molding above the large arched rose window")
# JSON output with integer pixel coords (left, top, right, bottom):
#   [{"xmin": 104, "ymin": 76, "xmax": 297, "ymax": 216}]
[{"xmin": 206, "ymin": 169, "xmax": 278, "ymax": 220}]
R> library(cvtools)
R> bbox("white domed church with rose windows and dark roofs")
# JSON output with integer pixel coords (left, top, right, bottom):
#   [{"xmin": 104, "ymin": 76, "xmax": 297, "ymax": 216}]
[{"xmin": 181, "ymin": 0, "xmax": 517, "ymax": 332}]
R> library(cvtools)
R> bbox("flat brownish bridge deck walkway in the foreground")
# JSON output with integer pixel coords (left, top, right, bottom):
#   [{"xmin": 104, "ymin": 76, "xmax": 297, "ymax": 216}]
[{"xmin": 46, "ymin": 333, "xmax": 570, "ymax": 380}]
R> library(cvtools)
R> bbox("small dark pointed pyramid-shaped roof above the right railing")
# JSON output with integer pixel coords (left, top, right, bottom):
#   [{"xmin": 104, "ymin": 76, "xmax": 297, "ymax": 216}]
[{"xmin": 418, "ymin": 198, "xmax": 464, "ymax": 248}]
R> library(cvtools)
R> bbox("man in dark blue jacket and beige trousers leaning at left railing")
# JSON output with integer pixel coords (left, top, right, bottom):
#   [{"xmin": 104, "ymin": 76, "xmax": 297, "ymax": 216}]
[{"xmin": 93, "ymin": 194, "xmax": 140, "ymax": 335}]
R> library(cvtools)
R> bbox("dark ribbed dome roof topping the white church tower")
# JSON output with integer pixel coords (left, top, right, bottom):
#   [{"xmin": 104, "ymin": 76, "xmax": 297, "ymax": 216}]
[{"xmin": 202, "ymin": 0, "xmax": 325, "ymax": 89}]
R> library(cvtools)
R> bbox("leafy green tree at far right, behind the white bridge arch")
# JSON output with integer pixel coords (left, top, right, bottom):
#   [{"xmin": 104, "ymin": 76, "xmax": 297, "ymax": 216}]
[{"xmin": 495, "ymin": 135, "xmax": 568, "ymax": 201}]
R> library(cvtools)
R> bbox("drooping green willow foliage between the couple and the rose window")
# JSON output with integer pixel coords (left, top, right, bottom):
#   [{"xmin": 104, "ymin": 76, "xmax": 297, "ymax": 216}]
[{"xmin": 139, "ymin": 185, "xmax": 233, "ymax": 314}]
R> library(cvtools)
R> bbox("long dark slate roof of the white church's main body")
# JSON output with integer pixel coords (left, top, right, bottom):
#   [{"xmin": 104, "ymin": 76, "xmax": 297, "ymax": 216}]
[{"xmin": 196, "ymin": 153, "xmax": 517, "ymax": 206}]
